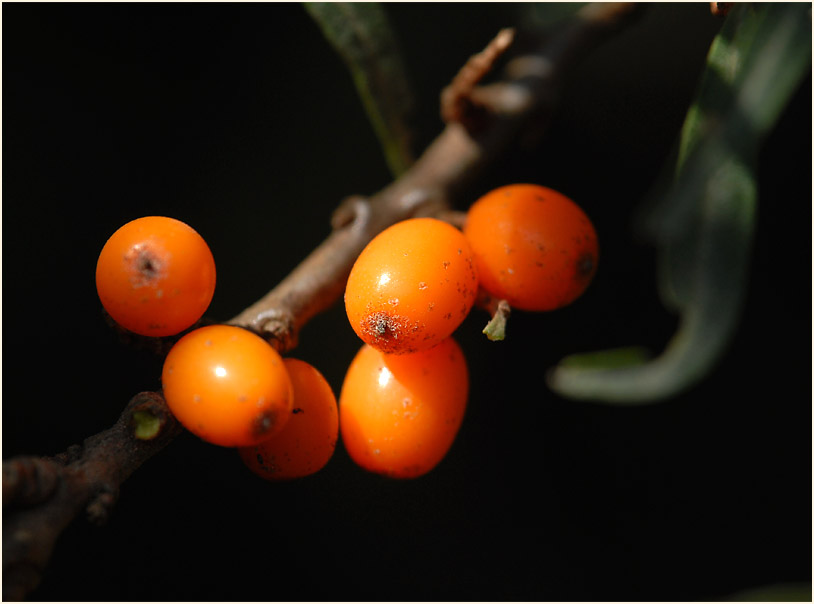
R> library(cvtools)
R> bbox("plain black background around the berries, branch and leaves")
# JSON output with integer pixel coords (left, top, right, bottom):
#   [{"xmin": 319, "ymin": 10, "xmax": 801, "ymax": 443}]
[{"xmin": 2, "ymin": 3, "xmax": 811, "ymax": 601}]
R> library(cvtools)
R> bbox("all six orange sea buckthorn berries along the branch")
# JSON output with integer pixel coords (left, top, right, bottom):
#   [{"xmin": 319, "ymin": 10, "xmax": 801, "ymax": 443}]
[{"xmin": 96, "ymin": 184, "xmax": 599, "ymax": 480}]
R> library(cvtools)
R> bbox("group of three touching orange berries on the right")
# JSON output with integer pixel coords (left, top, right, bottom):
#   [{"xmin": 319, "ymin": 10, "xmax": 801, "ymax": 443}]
[{"xmin": 339, "ymin": 184, "xmax": 599, "ymax": 478}]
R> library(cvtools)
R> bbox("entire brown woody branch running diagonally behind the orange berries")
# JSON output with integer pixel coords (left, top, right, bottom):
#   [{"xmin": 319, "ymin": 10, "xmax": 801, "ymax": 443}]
[{"xmin": 3, "ymin": 3, "xmax": 648, "ymax": 600}]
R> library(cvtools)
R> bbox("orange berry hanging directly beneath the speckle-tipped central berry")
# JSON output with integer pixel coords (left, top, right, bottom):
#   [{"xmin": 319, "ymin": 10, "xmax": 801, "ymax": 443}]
[{"xmin": 339, "ymin": 338, "xmax": 469, "ymax": 478}]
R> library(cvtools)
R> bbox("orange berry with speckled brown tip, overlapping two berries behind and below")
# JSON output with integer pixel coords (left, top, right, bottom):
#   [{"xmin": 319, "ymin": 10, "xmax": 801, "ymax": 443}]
[{"xmin": 345, "ymin": 218, "xmax": 478, "ymax": 354}]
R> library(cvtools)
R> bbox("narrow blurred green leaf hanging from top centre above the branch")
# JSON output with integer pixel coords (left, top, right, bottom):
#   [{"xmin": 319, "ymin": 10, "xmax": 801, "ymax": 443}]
[{"xmin": 304, "ymin": 2, "xmax": 414, "ymax": 176}]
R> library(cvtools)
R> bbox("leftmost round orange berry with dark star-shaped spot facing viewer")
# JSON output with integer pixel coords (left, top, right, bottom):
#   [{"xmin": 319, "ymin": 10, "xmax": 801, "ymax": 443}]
[{"xmin": 96, "ymin": 216, "xmax": 215, "ymax": 337}]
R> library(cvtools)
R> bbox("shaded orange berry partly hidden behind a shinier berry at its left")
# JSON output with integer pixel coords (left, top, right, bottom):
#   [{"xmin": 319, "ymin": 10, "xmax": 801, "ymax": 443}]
[{"xmin": 238, "ymin": 359, "xmax": 339, "ymax": 481}]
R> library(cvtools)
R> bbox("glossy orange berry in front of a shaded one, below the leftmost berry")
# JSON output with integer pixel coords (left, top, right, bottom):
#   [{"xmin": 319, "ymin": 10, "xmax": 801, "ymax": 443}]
[{"xmin": 161, "ymin": 325, "xmax": 293, "ymax": 447}]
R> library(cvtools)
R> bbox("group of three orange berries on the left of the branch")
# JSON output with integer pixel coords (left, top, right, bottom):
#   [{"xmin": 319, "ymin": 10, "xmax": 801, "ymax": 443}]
[{"xmin": 96, "ymin": 216, "xmax": 339, "ymax": 480}]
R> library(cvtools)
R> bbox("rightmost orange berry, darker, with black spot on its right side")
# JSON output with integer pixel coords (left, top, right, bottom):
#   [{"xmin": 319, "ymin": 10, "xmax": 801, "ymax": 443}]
[{"xmin": 464, "ymin": 184, "xmax": 599, "ymax": 311}]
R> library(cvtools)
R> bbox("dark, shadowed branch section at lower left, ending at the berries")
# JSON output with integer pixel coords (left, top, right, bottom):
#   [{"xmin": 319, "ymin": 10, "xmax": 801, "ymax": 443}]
[{"xmin": 3, "ymin": 392, "xmax": 181, "ymax": 600}]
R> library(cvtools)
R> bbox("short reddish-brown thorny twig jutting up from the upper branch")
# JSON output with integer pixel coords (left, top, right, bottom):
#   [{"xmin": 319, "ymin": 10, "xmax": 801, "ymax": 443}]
[{"xmin": 441, "ymin": 28, "xmax": 514, "ymax": 132}]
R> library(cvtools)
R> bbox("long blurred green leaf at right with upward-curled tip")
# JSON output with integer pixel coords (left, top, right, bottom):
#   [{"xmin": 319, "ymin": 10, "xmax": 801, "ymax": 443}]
[{"xmin": 549, "ymin": 3, "xmax": 811, "ymax": 404}]
